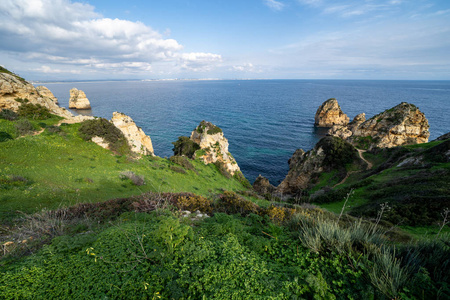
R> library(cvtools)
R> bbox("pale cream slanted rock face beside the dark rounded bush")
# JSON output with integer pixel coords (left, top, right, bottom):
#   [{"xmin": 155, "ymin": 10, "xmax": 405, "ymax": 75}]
[{"xmin": 111, "ymin": 112, "xmax": 154, "ymax": 155}]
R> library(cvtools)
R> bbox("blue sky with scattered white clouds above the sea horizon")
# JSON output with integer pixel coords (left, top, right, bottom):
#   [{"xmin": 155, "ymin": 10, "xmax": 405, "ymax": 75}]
[{"xmin": 0, "ymin": 0, "xmax": 450, "ymax": 80}]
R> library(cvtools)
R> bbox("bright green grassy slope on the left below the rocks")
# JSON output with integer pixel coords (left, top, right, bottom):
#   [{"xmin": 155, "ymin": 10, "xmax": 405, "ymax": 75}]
[{"xmin": 0, "ymin": 120, "xmax": 245, "ymax": 219}]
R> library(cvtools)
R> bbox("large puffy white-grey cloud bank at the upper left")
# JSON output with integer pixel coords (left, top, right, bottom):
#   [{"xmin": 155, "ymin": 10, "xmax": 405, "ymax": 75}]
[{"xmin": 0, "ymin": 0, "xmax": 221, "ymax": 76}]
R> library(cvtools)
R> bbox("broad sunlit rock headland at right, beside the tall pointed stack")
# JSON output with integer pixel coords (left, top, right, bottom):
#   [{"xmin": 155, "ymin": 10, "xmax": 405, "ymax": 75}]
[{"xmin": 328, "ymin": 102, "xmax": 430, "ymax": 149}]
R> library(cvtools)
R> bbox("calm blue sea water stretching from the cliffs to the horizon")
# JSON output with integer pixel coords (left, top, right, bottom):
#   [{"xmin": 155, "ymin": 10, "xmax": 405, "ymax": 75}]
[{"xmin": 44, "ymin": 80, "xmax": 450, "ymax": 185}]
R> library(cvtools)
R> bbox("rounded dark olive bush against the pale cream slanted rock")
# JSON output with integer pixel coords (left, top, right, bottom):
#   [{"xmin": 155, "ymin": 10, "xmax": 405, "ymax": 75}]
[{"xmin": 78, "ymin": 118, "xmax": 130, "ymax": 155}]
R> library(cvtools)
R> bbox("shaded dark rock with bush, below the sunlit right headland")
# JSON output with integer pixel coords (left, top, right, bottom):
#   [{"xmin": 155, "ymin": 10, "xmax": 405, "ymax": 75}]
[{"xmin": 276, "ymin": 136, "xmax": 359, "ymax": 194}]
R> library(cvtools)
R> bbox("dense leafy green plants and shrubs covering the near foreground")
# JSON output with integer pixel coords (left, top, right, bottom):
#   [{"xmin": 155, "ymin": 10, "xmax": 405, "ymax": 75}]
[{"xmin": 0, "ymin": 192, "xmax": 450, "ymax": 299}]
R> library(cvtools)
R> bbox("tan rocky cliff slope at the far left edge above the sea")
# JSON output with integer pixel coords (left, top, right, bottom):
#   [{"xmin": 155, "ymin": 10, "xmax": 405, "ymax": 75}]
[{"xmin": 0, "ymin": 73, "xmax": 73, "ymax": 118}]
